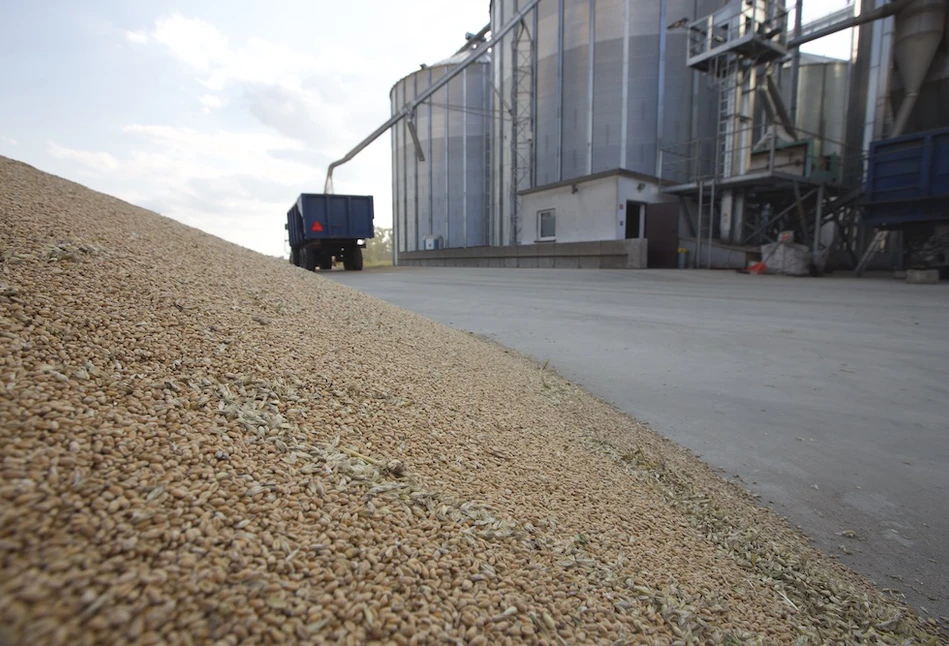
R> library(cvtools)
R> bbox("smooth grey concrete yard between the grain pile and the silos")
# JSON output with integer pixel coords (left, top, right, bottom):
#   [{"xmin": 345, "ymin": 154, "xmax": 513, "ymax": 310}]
[{"xmin": 328, "ymin": 268, "xmax": 949, "ymax": 616}]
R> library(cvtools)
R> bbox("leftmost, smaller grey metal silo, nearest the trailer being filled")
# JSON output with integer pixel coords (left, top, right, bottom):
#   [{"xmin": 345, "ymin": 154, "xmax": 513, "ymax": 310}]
[{"xmin": 389, "ymin": 51, "xmax": 491, "ymax": 252}]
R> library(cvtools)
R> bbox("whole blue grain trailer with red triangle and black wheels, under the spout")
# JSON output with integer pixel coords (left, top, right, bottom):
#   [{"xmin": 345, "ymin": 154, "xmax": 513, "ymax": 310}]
[{"xmin": 286, "ymin": 193, "xmax": 375, "ymax": 271}]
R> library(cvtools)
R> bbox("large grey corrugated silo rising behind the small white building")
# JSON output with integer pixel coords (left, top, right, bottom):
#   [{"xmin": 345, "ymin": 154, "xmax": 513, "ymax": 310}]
[{"xmin": 491, "ymin": 0, "xmax": 722, "ymax": 244}]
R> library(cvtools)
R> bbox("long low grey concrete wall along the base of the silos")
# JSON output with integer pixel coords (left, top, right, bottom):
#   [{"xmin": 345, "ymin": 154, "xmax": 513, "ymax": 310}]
[{"xmin": 399, "ymin": 238, "xmax": 648, "ymax": 269}]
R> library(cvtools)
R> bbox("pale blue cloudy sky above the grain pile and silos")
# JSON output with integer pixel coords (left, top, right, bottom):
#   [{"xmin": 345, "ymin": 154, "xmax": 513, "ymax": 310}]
[{"xmin": 0, "ymin": 0, "xmax": 850, "ymax": 256}]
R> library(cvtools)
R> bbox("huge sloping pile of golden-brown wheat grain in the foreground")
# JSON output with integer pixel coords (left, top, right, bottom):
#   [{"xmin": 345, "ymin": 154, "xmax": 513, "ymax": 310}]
[{"xmin": 0, "ymin": 158, "xmax": 938, "ymax": 644}]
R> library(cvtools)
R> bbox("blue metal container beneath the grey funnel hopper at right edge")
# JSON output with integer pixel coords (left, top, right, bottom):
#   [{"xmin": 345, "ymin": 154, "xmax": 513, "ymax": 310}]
[{"xmin": 863, "ymin": 128, "xmax": 949, "ymax": 228}]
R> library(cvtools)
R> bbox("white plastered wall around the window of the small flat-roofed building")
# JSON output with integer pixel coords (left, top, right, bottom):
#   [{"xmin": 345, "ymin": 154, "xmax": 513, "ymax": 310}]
[{"xmin": 520, "ymin": 176, "xmax": 623, "ymax": 245}]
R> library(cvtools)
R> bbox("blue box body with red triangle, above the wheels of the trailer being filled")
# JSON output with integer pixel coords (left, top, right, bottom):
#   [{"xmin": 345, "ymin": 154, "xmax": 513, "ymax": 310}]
[{"xmin": 287, "ymin": 193, "xmax": 375, "ymax": 248}]
